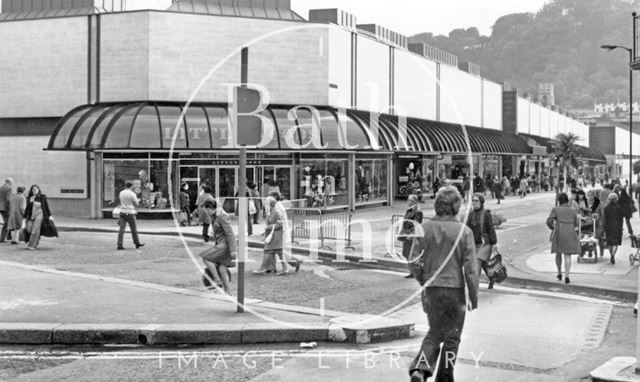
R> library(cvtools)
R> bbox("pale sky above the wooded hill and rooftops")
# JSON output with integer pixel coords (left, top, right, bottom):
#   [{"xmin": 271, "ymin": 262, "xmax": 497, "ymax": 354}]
[{"xmin": 291, "ymin": 0, "xmax": 549, "ymax": 36}]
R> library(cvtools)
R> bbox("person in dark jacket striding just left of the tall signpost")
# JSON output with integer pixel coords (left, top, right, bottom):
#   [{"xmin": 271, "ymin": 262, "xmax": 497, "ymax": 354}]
[{"xmin": 200, "ymin": 200, "xmax": 238, "ymax": 295}]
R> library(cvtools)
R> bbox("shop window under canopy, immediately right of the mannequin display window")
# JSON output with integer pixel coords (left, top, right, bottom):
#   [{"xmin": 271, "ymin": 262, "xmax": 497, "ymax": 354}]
[{"xmin": 356, "ymin": 158, "xmax": 389, "ymax": 204}]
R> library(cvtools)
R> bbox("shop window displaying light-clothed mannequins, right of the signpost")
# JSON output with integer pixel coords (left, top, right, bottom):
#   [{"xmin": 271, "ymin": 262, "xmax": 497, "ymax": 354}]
[{"xmin": 299, "ymin": 157, "xmax": 349, "ymax": 208}]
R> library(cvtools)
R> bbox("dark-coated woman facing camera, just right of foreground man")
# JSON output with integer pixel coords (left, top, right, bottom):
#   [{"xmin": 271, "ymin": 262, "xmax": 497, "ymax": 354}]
[{"xmin": 467, "ymin": 193, "xmax": 498, "ymax": 289}]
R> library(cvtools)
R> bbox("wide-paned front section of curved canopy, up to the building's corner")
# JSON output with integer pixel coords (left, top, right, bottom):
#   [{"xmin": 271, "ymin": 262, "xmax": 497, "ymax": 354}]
[{"xmin": 48, "ymin": 101, "xmax": 376, "ymax": 151}]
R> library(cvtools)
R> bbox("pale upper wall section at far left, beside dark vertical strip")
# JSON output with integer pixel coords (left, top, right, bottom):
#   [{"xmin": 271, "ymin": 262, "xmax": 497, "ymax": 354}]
[{"xmin": 0, "ymin": 17, "xmax": 88, "ymax": 118}]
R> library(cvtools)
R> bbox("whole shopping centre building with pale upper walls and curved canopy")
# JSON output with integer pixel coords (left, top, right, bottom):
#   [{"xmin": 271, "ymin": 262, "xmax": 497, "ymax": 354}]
[{"xmin": 0, "ymin": 0, "xmax": 605, "ymax": 217}]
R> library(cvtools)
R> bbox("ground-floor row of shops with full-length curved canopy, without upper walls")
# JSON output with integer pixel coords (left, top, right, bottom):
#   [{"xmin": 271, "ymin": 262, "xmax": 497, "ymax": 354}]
[{"xmin": 47, "ymin": 102, "xmax": 600, "ymax": 217}]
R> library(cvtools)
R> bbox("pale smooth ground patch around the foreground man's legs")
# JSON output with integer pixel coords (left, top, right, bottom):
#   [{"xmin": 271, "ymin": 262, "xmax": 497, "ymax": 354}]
[{"xmin": 382, "ymin": 293, "xmax": 613, "ymax": 369}]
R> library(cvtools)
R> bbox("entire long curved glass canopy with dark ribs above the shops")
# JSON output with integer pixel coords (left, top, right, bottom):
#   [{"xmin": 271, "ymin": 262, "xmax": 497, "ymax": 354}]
[{"xmin": 48, "ymin": 101, "xmax": 531, "ymax": 154}]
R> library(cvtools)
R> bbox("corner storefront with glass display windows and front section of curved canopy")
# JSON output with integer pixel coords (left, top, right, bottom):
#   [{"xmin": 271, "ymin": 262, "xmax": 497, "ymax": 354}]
[{"xmin": 48, "ymin": 102, "xmax": 402, "ymax": 218}]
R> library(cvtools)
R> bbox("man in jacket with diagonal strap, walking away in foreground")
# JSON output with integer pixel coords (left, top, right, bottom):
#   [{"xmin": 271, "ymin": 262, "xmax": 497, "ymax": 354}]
[{"xmin": 409, "ymin": 187, "xmax": 478, "ymax": 382}]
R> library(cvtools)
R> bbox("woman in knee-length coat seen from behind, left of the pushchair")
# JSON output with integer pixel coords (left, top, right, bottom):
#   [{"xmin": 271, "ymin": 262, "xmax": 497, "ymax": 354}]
[{"xmin": 547, "ymin": 192, "xmax": 581, "ymax": 284}]
